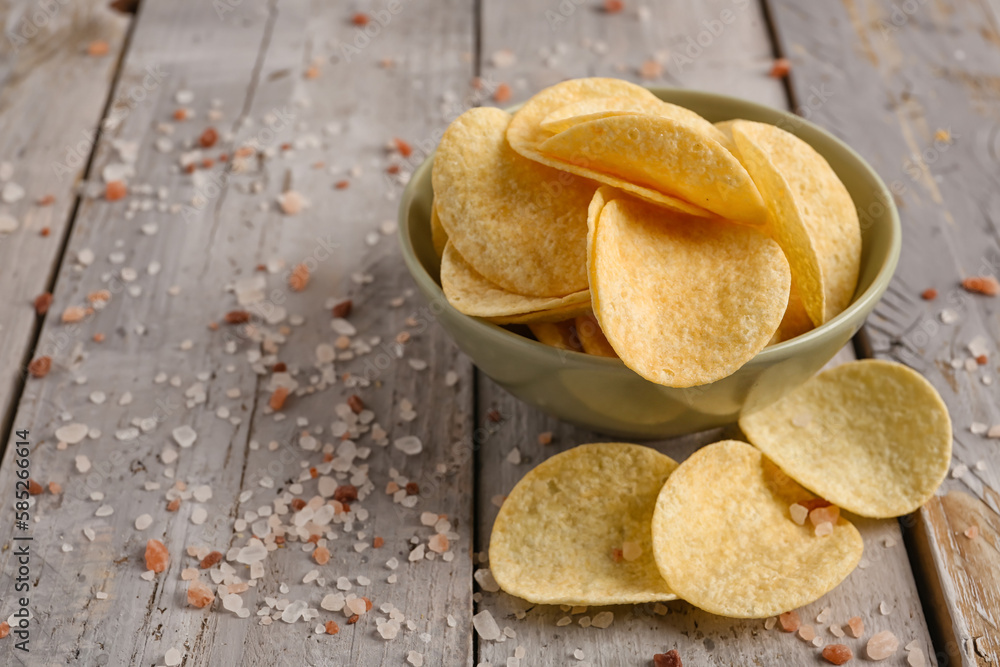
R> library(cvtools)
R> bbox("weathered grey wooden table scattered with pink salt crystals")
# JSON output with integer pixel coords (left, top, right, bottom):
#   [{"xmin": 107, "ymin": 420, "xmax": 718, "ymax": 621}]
[{"xmin": 0, "ymin": 0, "xmax": 1000, "ymax": 667}]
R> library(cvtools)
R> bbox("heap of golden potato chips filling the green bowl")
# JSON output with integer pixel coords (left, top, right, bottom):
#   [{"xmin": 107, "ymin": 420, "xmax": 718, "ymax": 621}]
[{"xmin": 432, "ymin": 78, "xmax": 862, "ymax": 388}]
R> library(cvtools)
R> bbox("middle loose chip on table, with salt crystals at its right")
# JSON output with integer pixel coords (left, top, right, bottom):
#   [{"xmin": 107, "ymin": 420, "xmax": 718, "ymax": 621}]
[{"xmin": 653, "ymin": 440, "xmax": 864, "ymax": 618}]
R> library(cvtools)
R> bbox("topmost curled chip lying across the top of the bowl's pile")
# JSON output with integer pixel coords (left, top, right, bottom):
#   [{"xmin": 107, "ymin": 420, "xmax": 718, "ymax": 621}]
[{"xmin": 538, "ymin": 114, "xmax": 767, "ymax": 225}]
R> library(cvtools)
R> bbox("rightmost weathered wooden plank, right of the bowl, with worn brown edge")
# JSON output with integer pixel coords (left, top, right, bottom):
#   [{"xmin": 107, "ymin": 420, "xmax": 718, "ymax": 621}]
[{"xmin": 770, "ymin": 0, "xmax": 1000, "ymax": 665}]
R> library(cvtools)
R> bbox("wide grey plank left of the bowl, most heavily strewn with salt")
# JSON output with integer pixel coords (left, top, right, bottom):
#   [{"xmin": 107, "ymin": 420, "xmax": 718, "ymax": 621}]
[{"xmin": 0, "ymin": 0, "xmax": 473, "ymax": 665}]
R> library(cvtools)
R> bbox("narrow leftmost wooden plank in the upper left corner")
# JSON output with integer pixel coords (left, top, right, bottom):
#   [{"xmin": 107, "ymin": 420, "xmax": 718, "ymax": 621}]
[{"xmin": 0, "ymin": 0, "xmax": 130, "ymax": 440}]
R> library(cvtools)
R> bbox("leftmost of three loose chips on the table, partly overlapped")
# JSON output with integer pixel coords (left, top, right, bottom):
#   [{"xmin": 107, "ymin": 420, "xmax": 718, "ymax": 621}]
[{"xmin": 489, "ymin": 442, "xmax": 677, "ymax": 605}]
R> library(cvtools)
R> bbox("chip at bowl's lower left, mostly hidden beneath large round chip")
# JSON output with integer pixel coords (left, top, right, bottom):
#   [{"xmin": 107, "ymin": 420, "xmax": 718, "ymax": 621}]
[{"xmin": 441, "ymin": 240, "xmax": 590, "ymax": 324}]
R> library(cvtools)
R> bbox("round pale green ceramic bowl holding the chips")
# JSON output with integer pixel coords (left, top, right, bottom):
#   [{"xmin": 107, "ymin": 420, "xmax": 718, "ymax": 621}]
[{"xmin": 399, "ymin": 88, "xmax": 900, "ymax": 438}]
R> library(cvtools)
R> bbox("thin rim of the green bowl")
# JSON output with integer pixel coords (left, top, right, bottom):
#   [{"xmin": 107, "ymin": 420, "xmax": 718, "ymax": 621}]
[{"xmin": 397, "ymin": 86, "xmax": 902, "ymax": 373}]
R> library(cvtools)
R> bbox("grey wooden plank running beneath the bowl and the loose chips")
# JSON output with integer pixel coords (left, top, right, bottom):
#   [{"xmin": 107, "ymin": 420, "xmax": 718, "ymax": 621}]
[{"xmin": 476, "ymin": 2, "xmax": 933, "ymax": 665}]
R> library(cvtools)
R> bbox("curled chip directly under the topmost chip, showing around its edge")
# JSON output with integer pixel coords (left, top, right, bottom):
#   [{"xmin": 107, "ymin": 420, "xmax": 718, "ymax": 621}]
[{"xmin": 507, "ymin": 78, "xmax": 712, "ymax": 217}]
